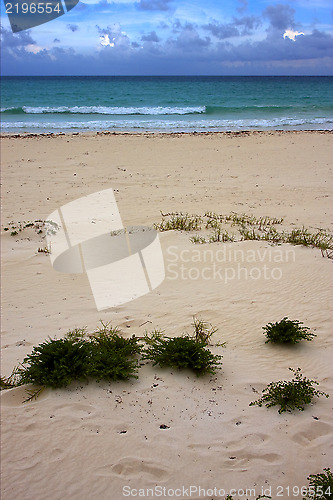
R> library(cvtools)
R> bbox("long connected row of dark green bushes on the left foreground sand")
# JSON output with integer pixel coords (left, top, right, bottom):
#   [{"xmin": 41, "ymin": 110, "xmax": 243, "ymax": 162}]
[{"xmin": 1, "ymin": 317, "xmax": 222, "ymax": 399}]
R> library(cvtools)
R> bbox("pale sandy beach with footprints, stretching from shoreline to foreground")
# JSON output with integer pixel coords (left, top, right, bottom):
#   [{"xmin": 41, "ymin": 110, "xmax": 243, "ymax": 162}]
[{"xmin": 1, "ymin": 131, "xmax": 333, "ymax": 500}]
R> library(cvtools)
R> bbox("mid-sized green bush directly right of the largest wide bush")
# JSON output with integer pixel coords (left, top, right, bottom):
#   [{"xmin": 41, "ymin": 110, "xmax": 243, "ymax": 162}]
[{"xmin": 142, "ymin": 331, "xmax": 221, "ymax": 377}]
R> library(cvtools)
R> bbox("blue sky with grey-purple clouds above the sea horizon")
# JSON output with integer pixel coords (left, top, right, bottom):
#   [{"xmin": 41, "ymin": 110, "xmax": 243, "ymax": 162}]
[{"xmin": 0, "ymin": 0, "xmax": 333, "ymax": 76}]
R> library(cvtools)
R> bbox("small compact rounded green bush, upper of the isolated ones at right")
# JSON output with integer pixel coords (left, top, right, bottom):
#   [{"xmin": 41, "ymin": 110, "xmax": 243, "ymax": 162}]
[{"xmin": 263, "ymin": 318, "xmax": 316, "ymax": 344}]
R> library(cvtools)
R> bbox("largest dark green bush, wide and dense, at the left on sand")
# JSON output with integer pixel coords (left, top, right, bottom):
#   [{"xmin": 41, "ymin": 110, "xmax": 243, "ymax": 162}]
[{"xmin": 13, "ymin": 325, "xmax": 141, "ymax": 388}]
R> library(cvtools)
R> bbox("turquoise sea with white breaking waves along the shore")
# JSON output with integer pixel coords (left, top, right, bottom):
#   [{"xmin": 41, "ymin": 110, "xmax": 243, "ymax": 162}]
[{"xmin": 0, "ymin": 76, "xmax": 333, "ymax": 133}]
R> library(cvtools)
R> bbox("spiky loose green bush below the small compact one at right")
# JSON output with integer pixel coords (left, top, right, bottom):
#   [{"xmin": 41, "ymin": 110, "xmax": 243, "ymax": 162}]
[{"xmin": 250, "ymin": 368, "xmax": 329, "ymax": 413}]
